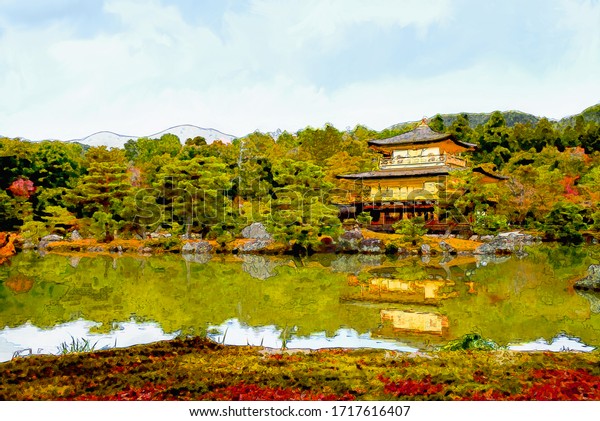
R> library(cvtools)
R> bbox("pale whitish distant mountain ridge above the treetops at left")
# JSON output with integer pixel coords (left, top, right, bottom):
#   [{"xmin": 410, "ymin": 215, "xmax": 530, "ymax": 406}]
[{"xmin": 70, "ymin": 124, "xmax": 236, "ymax": 148}]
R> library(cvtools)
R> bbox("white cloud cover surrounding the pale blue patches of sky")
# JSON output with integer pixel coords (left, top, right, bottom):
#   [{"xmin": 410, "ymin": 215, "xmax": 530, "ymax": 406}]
[{"xmin": 0, "ymin": 0, "xmax": 600, "ymax": 139}]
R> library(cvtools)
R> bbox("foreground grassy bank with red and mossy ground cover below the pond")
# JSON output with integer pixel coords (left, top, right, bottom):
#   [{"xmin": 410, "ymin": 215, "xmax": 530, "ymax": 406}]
[{"xmin": 0, "ymin": 338, "xmax": 600, "ymax": 400}]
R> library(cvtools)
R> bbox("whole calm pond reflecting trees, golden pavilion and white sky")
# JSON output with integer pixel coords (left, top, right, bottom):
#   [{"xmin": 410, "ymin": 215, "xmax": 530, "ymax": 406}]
[{"xmin": 0, "ymin": 247, "xmax": 600, "ymax": 361}]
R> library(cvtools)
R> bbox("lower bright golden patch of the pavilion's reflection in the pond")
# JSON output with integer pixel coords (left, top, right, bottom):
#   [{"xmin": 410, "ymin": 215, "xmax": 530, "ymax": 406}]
[{"xmin": 380, "ymin": 309, "xmax": 448, "ymax": 335}]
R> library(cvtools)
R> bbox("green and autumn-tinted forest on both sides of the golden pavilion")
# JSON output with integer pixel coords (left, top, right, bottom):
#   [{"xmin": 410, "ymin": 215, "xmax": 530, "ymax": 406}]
[{"xmin": 0, "ymin": 105, "xmax": 600, "ymax": 248}]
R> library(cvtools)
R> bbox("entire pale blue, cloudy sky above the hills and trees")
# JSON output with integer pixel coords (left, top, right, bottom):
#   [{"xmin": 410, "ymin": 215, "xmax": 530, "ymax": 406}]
[{"xmin": 0, "ymin": 0, "xmax": 600, "ymax": 140}]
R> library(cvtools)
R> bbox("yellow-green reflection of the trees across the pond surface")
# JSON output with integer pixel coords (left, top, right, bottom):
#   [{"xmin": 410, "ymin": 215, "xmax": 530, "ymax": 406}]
[{"xmin": 0, "ymin": 248, "xmax": 600, "ymax": 345}]
